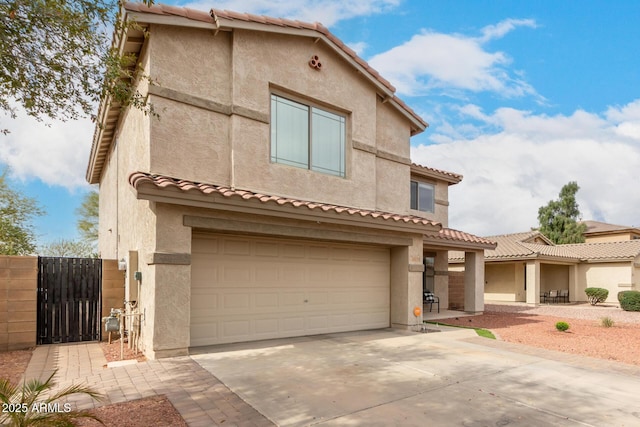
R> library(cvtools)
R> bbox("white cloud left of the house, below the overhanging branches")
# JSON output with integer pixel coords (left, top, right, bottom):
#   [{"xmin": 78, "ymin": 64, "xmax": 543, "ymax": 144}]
[{"xmin": 0, "ymin": 113, "xmax": 95, "ymax": 190}]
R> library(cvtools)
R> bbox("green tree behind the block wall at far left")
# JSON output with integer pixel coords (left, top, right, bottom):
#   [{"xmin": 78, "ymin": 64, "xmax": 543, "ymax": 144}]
[{"xmin": 0, "ymin": 170, "xmax": 44, "ymax": 255}]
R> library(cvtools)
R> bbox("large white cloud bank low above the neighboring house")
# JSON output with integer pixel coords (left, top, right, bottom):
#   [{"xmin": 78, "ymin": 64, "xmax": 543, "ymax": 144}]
[{"xmin": 411, "ymin": 100, "xmax": 640, "ymax": 236}]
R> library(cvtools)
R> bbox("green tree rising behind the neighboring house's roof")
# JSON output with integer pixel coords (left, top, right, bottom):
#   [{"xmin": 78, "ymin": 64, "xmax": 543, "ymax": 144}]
[{"xmin": 538, "ymin": 181, "xmax": 587, "ymax": 244}]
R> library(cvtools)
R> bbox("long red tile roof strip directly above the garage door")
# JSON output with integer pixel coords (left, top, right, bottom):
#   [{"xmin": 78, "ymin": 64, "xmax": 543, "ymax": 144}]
[{"xmin": 129, "ymin": 172, "xmax": 441, "ymax": 228}]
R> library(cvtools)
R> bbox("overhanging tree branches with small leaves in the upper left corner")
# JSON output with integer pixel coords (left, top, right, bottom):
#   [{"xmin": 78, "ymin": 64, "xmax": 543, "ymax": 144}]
[{"xmin": 0, "ymin": 0, "xmax": 153, "ymax": 134}]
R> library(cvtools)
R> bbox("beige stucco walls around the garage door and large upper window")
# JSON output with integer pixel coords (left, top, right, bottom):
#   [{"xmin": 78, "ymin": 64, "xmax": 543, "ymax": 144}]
[{"xmin": 100, "ymin": 25, "xmax": 436, "ymax": 358}]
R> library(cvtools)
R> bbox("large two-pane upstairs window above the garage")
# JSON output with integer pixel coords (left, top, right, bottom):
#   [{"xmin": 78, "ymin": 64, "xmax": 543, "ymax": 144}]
[{"xmin": 270, "ymin": 93, "xmax": 347, "ymax": 178}]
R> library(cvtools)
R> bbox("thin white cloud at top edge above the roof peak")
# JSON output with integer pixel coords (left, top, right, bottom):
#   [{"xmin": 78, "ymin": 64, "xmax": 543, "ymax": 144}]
[{"xmin": 183, "ymin": 0, "xmax": 402, "ymax": 27}]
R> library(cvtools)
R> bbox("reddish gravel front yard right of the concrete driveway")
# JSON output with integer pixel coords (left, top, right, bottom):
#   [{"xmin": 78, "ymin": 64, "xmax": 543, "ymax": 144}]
[{"xmin": 438, "ymin": 312, "xmax": 640, "ymax": 365}]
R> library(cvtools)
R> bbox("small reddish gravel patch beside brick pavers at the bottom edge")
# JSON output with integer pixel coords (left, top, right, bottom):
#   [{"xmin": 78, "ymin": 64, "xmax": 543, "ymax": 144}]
[{"xmin": 77, "ymin": 396, "xmax": 187, "ymax": 427}]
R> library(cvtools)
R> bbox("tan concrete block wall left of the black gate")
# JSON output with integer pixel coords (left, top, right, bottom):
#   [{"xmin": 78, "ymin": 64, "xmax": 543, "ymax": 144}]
[{"xmin": 0, "ymin": 255, "xmax": 38, "ymax": 351}]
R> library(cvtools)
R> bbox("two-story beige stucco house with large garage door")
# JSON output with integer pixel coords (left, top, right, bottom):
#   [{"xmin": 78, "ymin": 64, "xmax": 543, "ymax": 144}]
[{"xmin": 87, "ymin": 2, "xmax": 495, "ymax": 358}]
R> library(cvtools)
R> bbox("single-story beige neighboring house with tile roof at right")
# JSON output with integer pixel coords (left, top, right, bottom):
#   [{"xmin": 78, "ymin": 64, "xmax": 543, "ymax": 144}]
[{"xmin": 449, "ymin": 231, "xmax": 640, "ymax": 304}]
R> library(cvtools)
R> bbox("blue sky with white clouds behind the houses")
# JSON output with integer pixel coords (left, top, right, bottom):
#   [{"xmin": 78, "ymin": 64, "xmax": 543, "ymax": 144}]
[{"xmin": 0, "ymin": 0, "xmax": 640, "ymax": 243}]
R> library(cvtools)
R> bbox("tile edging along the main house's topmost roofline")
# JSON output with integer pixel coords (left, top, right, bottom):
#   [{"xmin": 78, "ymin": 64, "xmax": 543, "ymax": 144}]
[{"xmin": 124, "ymin": 1, "xmax": 429, "ymax": 127}]
